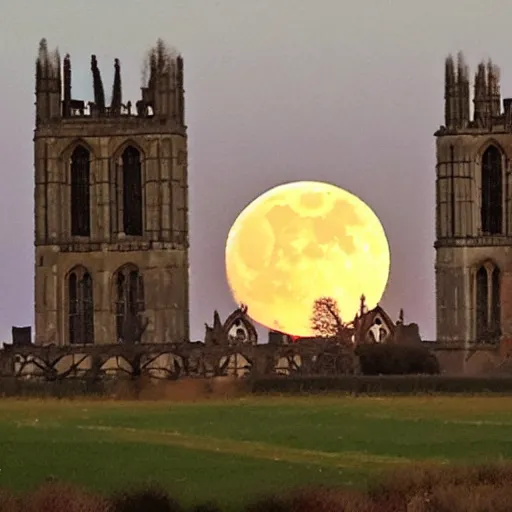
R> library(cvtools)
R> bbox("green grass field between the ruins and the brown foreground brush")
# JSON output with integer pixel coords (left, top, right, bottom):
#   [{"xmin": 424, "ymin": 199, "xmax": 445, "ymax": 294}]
[{"xmin": 0, "ymin": 397, "xmax": 512, "ymax": 506}]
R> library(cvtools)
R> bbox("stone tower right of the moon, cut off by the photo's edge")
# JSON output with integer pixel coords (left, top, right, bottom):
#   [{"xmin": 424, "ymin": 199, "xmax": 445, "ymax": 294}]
[{"xmin": 435, "ymin": 54, "xmax": 512, "ymax": 346}]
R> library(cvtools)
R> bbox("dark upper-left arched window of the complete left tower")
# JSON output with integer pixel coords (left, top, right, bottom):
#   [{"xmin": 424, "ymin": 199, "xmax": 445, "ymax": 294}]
[{"xmin": 71, "ymin": 146, "xmax": 91, "ymax": 236}]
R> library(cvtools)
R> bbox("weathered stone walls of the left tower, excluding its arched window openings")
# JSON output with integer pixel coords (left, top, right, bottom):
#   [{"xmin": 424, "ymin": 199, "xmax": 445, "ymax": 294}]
[{"xmin": 34, "ymin": 39, "xmax": 189, "ymax": 345}]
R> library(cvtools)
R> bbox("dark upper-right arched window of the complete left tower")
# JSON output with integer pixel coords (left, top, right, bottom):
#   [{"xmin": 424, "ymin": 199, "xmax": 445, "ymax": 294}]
[{"xmin": 121, "ymin": 146, "xmax": 142, "ymax": 236}]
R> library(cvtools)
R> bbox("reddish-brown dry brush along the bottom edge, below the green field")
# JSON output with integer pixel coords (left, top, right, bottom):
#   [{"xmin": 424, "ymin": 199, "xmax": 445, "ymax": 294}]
[{"xmin": 0, "ymin": 464, "xmax": 512, "ymax": 512}]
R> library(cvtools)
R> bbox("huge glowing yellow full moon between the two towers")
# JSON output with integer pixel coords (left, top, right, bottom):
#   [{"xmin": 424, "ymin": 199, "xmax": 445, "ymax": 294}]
[{"xmin": 226, "ymin": 181, "xmax": 390, "ymax": 336}]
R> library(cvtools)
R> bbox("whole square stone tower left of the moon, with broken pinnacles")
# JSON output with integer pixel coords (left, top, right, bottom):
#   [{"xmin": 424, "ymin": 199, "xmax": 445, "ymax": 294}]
[{"xmin": 34, "ymin": 40, "xmax": 189, "ymax": 345}]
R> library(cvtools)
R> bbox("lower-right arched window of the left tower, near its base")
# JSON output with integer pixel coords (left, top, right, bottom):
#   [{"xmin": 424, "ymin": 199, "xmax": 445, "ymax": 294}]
[{"xmin": 114, "ymin": 265, "xmax": 145, "ymax": 343}]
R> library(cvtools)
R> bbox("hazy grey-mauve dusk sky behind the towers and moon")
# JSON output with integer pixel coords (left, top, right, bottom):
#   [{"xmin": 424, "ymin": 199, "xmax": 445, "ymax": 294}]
[{"xmin": 0, "ymin": 0, "xmax": 512, "ymax": 341}]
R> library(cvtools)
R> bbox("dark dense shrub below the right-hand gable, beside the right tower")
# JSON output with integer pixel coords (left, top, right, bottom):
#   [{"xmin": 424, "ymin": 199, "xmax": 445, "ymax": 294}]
[{"xmin": 356, "ymin": 343, "xmax": 440, "ymax": 375}]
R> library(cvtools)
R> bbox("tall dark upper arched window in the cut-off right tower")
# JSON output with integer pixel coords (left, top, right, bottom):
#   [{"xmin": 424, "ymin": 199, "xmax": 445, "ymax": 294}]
[{"xmin": 481, "ymin": 146, "xmax": 503, "ymax": 235}]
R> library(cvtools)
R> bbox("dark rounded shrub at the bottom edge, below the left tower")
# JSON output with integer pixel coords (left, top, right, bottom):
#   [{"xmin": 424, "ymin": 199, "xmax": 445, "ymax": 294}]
[{"xmin": 111, "ymin": 487, "xmax": 182, "ymax": 512}]
